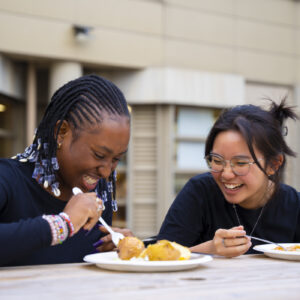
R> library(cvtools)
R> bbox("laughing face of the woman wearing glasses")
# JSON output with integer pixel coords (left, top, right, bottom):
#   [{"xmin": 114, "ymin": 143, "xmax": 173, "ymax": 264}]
[{"xmin": 211, "ymin": 130, "xmax": 272, "ymax": 209}]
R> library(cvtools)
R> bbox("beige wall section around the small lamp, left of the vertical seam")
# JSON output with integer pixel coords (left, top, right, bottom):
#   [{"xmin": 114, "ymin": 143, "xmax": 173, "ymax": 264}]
[{"xmin": 0, "ymin": 0, "xmax": 163, "ymax": 68}]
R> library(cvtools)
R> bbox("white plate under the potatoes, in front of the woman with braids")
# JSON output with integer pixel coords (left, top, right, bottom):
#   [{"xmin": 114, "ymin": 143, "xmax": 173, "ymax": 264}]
[{"xmin": 83, "ymin": 252, "xmax": 212, "ymax": 272}]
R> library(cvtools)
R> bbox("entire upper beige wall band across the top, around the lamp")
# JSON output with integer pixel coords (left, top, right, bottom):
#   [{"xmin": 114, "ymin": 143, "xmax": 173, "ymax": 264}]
[{"xmin": 0, "ymin": 0, "xmax": 300, "ymax": 85}]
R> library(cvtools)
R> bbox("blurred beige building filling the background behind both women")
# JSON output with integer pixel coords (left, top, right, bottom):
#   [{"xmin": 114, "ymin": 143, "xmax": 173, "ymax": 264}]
[{"xmin": 0, "ymin": 0, "xmax": 300, "ymax": 238}]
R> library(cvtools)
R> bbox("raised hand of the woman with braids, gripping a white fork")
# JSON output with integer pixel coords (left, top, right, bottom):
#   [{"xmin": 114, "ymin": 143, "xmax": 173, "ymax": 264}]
[{"xmin": 64, "ymin": 193, "xmax": 103, "ymax": 233}]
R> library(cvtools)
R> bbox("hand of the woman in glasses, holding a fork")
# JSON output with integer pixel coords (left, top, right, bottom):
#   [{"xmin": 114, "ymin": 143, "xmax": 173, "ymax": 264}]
[{"xmin": 212, "ymin": 226, "xmax": 252, "ymax": 257}]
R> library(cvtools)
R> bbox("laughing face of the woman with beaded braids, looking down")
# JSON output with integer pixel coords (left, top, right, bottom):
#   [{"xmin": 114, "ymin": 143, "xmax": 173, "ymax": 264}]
[{"xmin": 57, "ymin": 115, "xmax": 130, "ymax": 200}]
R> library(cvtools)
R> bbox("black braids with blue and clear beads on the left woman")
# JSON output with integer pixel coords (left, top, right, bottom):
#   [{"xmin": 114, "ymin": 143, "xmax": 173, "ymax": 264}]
[{"xmin": 14, "ymin": 75, "xmax": 130, "ymax": 210}]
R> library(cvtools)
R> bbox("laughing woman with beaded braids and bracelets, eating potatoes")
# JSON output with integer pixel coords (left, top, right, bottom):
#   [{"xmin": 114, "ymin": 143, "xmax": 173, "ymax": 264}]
[{"xmin": 0, "ymin": 75, "xmax": 131, "ymax": 266}]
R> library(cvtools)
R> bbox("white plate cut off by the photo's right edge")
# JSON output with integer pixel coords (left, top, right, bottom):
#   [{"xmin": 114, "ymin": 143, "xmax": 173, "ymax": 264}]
[{"xmin": 253, "ymin": 243, "xmax": 300, "ymax": 260}]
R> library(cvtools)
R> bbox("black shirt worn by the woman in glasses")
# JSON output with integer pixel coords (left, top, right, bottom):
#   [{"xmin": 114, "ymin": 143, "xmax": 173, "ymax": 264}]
[{"xmin": 157, "ymin": 173, "xmax": 300, "ymax": 254}]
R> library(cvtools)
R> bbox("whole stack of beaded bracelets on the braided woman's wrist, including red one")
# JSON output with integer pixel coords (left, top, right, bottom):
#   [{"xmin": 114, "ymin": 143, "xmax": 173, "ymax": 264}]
[{"xmin": 43, "ymin": 212, "xmax": 74, "ymax": 246}]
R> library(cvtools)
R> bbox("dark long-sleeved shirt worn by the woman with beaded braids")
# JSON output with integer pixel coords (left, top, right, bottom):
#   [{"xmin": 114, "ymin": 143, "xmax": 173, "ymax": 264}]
[{"xmin": 0, "ymin": 159, "xmax": 112, "ymax": 266}]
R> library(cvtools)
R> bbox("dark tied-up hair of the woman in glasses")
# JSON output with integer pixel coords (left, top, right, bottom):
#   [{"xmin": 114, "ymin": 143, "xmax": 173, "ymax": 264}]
[{"xmin": 205, "ymin": 97, "xmax": 298, "ymax": 190}]
